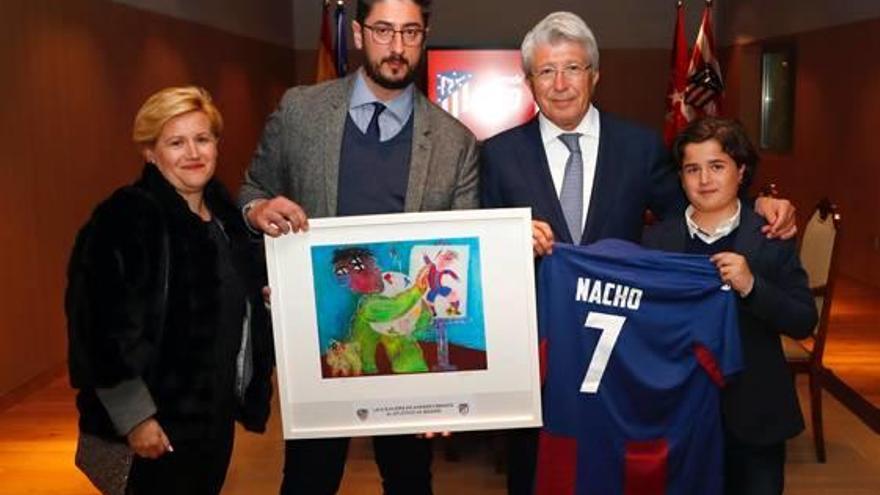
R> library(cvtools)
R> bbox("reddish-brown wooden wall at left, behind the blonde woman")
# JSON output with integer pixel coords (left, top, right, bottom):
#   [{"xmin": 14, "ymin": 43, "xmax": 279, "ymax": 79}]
[{"xmin": 0, "ymin": 0, "xmax": 294, "ymax": 396}]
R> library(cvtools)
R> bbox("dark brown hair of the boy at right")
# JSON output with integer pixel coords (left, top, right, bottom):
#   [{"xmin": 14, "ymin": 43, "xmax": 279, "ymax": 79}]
[{"xmin": 672, "ymin": 117, "xmax": 759, "ymax": 190}]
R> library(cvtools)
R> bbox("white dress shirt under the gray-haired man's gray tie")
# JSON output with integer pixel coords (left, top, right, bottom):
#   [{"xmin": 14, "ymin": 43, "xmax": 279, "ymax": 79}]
[{"xmin": 538, "ymin": 105, "xmax": 599, "ymax": 231}]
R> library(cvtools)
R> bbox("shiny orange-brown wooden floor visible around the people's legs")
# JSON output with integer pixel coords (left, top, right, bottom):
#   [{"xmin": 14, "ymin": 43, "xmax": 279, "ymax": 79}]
[{"xmin": 0, "ymin": 281, "xmax": 880, "ymax": 495}]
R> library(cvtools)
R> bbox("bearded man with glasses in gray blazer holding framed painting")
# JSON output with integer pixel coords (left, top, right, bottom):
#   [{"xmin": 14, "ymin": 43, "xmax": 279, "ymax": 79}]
[{"xmin": 240, "ymin": 0, "xmax": 479, "ymax": 495}]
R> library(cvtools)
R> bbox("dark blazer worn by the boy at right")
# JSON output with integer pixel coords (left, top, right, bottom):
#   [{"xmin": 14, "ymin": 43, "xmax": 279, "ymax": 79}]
[{"xmin": 644, "ymin": 204, "xmax": 817, "ymax": 445}]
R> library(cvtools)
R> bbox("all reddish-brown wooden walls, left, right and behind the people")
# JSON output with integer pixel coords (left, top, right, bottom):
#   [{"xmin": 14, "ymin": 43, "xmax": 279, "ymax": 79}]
[{"xmin": 0, "ymin": 0, "xmax": 880, "ymax": 397}]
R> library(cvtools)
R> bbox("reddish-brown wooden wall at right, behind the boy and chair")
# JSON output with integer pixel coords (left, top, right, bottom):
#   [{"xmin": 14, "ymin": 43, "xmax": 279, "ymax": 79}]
[{"xmin": 728, "ymin": 19, "xmax": 880, "ymax": 287}]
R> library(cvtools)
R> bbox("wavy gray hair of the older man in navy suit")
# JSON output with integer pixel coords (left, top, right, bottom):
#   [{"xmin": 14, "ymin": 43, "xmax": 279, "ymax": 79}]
[{"xmin": 520, "ymin": 12, "xmax": 599, "ymax": 74}]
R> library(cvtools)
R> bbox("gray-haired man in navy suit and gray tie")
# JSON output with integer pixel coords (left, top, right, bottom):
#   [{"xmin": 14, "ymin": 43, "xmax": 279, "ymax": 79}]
[{"xmin": 480, "ymin": 12, "xmax": 796, "ymax": 494}]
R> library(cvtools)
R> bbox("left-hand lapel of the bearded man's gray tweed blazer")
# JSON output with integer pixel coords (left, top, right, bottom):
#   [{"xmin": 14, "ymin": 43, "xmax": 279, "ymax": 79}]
[{"xmin": 322, "ymin": 76, "xmax": 357, "ymax": 216}]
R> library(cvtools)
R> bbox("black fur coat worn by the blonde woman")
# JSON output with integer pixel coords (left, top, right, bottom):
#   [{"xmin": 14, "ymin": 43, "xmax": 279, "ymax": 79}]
[{"xmin": 67, "ymin": 164, "xmax": 274, "ymax": 437}]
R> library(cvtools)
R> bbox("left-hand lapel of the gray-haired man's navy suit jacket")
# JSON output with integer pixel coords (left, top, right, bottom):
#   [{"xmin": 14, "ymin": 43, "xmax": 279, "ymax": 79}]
[{"xmin": 516, "ymin": 116, "xmax": 572, "ymax": 246}]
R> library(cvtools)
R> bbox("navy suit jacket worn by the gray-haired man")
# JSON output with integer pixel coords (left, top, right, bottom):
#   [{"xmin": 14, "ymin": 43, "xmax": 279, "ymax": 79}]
[{"xmin": 480, "ymin": 112, "xmax": 684, "ymax": 244}]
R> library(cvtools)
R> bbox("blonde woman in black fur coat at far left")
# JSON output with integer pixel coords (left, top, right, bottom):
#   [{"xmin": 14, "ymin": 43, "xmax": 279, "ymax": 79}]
[{"xmin": 66, "ymin": 87, "xmax": 272, "ymax": 494}]
